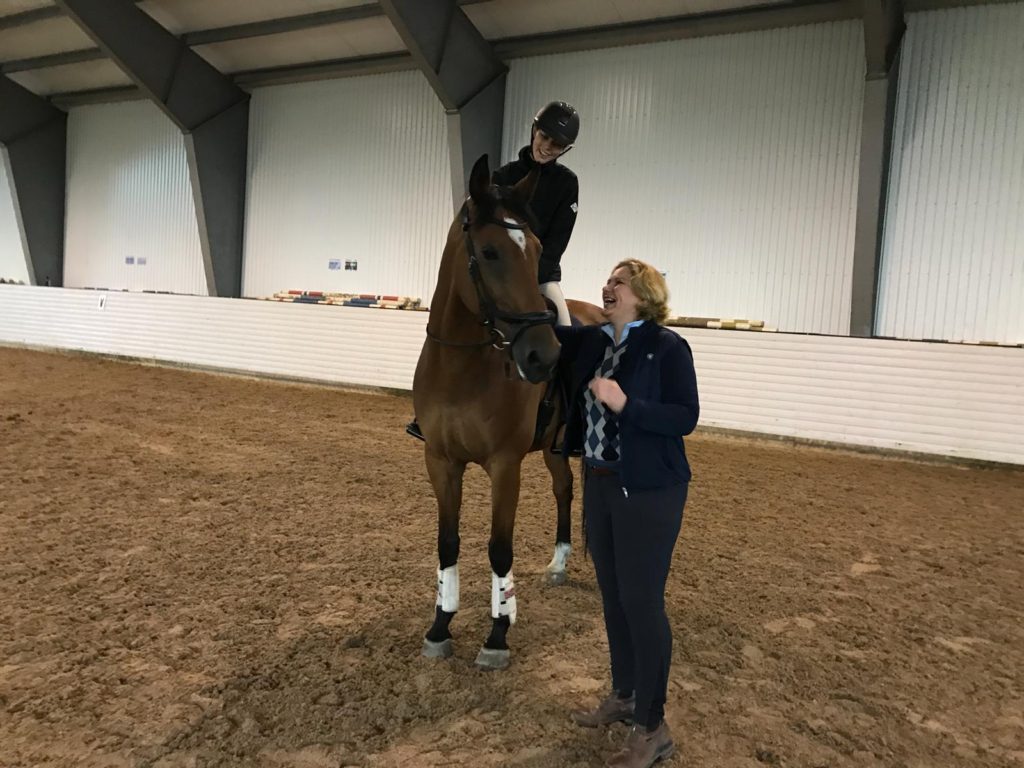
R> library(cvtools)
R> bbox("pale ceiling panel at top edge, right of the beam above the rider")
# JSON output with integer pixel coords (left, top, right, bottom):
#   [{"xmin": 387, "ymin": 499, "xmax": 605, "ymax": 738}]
[{"xmin": 462, "ymin": 0, "xmax": 785, "ymax": 40}]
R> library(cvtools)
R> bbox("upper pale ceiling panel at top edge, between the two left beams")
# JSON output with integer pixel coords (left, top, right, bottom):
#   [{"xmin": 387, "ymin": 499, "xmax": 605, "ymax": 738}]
[{"xmin": 139, "ymin": 0, "xmax": 369, "ymax": 35}]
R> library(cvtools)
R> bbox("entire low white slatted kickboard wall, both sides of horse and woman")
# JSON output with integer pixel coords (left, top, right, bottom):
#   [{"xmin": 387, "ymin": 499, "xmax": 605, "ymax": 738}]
[{"xmin": 0, "ymin": 286, "xmax": 1024, "ymax": 464}]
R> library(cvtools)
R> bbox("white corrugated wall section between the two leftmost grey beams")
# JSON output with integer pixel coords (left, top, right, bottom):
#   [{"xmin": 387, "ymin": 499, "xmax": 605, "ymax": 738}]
[{"xmin": 65, "ymin": 101, "xmax": 209, "ymax": 295}]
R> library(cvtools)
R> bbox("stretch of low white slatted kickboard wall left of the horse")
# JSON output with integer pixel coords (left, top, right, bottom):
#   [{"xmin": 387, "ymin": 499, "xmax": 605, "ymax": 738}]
[{"xmin": 0, "ymin": 286, "xmax": 427, "ymax": 389}]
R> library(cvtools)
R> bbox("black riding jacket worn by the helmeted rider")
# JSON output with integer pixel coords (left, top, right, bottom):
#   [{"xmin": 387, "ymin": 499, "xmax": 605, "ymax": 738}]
[{"xmin": 494, "ymin": 145, "xmax": 580, "ymax": 283}]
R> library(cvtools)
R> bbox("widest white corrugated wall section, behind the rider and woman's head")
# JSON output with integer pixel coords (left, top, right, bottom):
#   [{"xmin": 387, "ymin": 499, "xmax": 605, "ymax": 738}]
[{"xmin": 504, "ymin": 22, "xmax": 864, "ymax": 334}]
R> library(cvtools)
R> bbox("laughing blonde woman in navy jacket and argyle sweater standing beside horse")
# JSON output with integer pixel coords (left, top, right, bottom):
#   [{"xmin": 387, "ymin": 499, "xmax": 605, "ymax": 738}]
[{"xmin": 555, "ymin": 259, "xmax": 699, "ymax": 768}]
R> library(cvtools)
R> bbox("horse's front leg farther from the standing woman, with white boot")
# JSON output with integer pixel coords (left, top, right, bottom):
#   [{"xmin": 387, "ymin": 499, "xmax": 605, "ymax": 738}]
[{"xmin": 423, "ymin": 447, "xmax": 466, "ymax": 658}]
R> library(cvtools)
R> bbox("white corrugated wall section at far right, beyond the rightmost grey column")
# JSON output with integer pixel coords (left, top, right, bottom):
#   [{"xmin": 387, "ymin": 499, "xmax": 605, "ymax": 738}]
[{"xmin": 876, "ymin": 3, "xmax": 1024, "ymax": 343}]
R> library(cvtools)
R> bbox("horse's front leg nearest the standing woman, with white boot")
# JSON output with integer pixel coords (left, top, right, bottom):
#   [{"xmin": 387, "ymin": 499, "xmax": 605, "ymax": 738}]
[{"xmin": 476, "ymin": 456, "xmax": 522, "ymax": 670}]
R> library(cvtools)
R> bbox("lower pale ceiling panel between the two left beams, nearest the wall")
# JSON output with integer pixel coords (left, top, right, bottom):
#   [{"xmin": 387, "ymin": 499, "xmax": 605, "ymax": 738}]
[{"xmin": 194, "ymin": 16, "xmax": 406, "ymax": 72}]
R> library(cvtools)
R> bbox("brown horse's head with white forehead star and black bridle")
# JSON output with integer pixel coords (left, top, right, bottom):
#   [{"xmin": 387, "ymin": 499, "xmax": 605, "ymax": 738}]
[{"xmin": 446, "ymin": 155, "xmax": 559, "ymax": 383}]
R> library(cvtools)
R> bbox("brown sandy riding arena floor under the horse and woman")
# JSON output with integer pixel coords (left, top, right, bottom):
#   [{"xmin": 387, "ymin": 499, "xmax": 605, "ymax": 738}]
[{"xmin": 0, "ymin": 349, "xmax": 1024, "ymax": 768}]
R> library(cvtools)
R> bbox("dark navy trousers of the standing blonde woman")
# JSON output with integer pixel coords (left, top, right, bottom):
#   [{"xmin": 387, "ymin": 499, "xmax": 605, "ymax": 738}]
[{"xmin": 583, "ymin": 468, "xmax": 689, "ymax": 728}]
